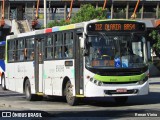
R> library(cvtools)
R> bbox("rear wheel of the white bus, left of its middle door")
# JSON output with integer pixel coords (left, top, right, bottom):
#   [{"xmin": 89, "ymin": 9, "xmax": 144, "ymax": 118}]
[{"xmin": 25, "ymin": 80, "xmax": 35, "ymax": 101}]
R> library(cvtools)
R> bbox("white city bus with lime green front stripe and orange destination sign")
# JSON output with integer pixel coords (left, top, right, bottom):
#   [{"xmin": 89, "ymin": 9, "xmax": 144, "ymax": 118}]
[{"xmin": 3, "ymin": 19, "xmax": 149, "ymax": 106}]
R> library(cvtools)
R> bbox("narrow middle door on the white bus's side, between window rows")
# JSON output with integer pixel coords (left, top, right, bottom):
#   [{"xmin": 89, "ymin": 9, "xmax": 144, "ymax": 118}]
[{"xmin": 34, "ymin": 37, "xmax": 44, "ymax": 93}]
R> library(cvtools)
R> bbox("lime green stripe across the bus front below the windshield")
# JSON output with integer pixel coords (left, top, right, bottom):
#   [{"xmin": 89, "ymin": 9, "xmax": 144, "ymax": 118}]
[{"xmin": 93, "ymin": 74, "xmax": 146, "ymax": 82}]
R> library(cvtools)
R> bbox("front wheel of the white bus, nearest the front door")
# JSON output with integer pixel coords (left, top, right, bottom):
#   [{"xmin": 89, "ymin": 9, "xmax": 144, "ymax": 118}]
[{"xmin": 66, "ymin": 81, "xmax": 77, "ymax": 106}]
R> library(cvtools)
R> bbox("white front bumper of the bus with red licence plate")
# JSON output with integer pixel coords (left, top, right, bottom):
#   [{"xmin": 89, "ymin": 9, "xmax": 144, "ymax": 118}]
[{"xmin": 84, "ymin": 81, "xmax": 149, "ymax": 97}]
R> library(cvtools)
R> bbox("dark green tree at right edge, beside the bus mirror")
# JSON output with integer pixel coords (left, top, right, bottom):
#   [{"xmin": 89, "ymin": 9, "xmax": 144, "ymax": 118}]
[{"xmin": 149, "ymin": 30, "xmax": 160, "ymax": 58}]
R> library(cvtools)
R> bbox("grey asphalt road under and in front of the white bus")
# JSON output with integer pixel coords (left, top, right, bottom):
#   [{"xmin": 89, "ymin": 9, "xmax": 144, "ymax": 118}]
[{"xmin": 0, "ymin": 78, "xmax": 160, "ymax": 119}]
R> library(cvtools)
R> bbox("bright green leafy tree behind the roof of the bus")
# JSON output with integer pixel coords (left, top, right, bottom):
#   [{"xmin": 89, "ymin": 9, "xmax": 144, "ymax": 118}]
[{"xmin": 47, "ymin": 4, "xmax": 106, "ymax": 28}]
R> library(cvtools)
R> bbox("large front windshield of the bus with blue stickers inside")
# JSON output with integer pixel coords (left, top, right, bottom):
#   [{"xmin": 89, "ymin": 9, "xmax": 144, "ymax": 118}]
[{"xmin": 86, "ymin": 32, "xmax": 147, "ymax": 68}]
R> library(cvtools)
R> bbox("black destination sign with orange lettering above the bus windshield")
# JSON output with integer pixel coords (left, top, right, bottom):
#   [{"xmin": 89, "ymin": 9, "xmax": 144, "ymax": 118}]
[{"xmin": 87, "ymin": 23, "xmax": 145, "ymax": 31}]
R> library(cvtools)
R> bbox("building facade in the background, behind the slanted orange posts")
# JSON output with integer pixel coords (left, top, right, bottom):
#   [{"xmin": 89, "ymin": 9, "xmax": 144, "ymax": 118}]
[{"xmin": 0, "ymin": 0, "xmax": 160, "ymax": 27}]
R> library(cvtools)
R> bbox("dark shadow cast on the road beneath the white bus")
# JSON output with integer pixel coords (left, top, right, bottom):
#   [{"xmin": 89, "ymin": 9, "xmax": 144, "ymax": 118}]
[{"xmin": 44, "ymin": 92, "xmax": 160, "ymax": 107}]
